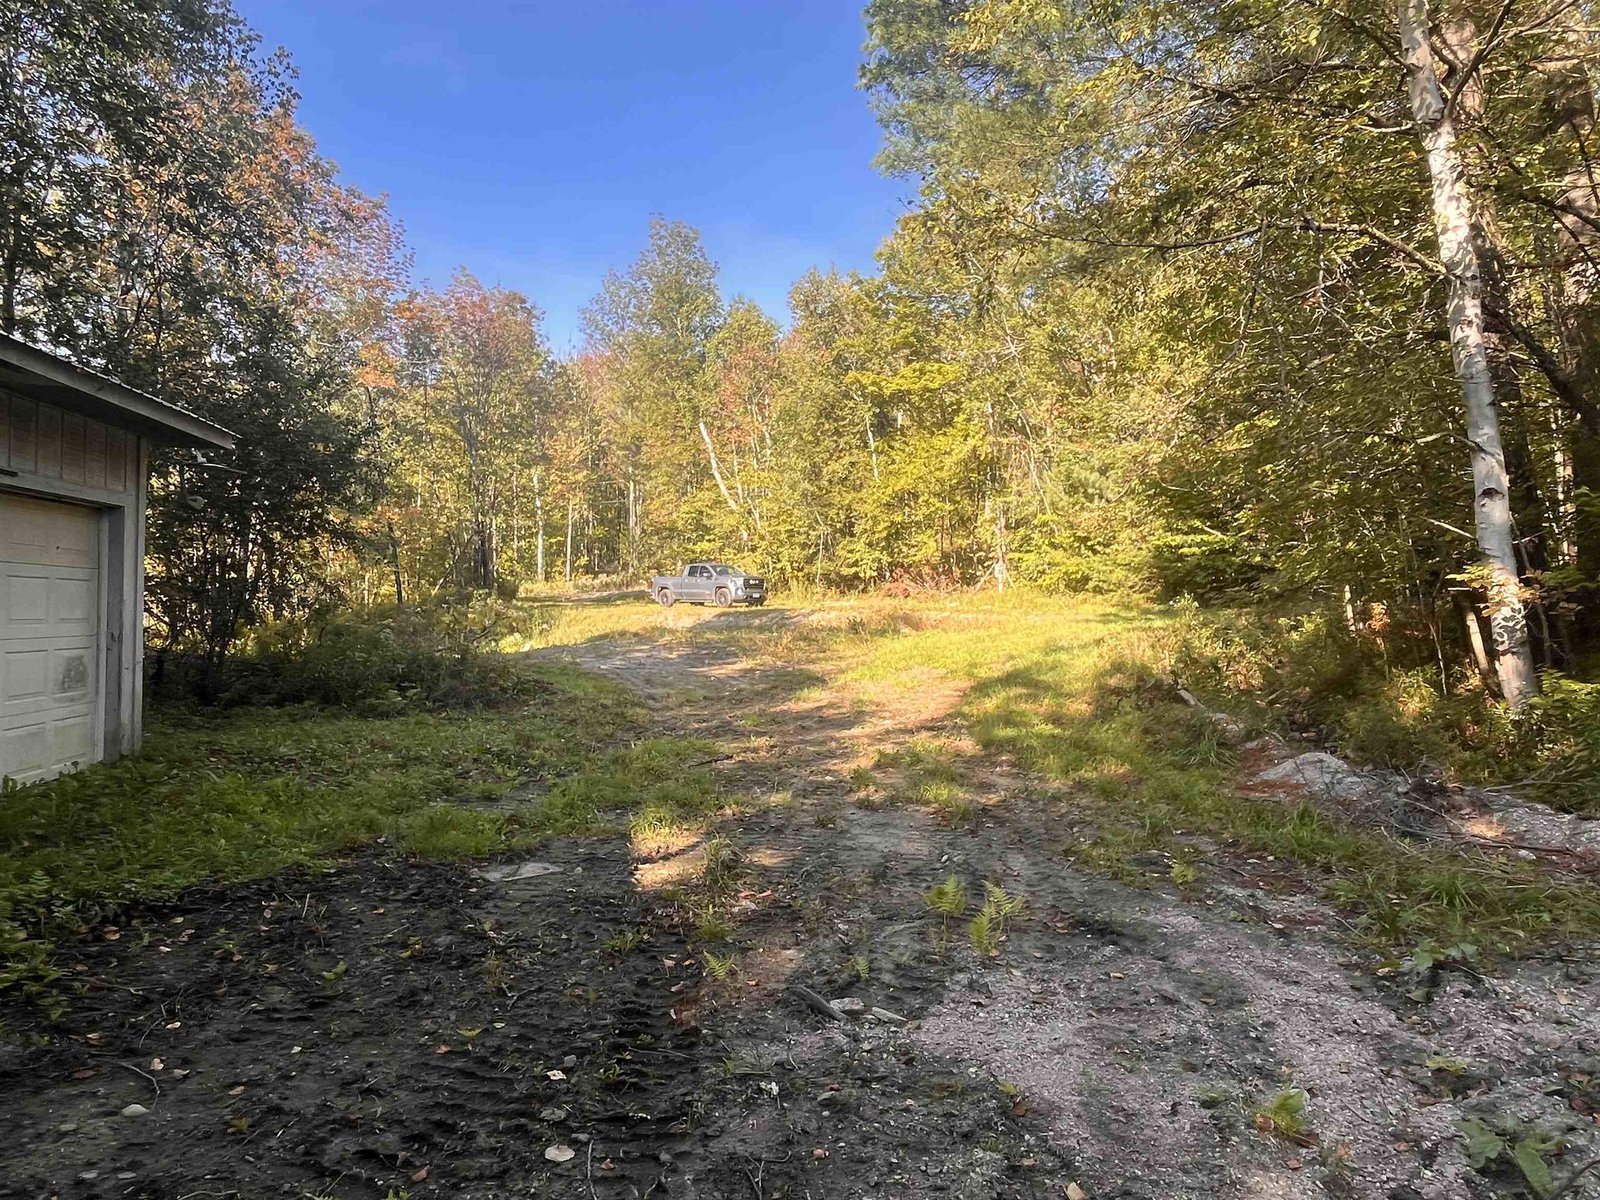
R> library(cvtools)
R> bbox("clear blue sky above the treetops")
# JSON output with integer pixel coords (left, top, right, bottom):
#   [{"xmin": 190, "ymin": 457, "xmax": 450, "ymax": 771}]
[{"xmin": 235, "ymin": 0, "xmax": 912, "ymax": 350}]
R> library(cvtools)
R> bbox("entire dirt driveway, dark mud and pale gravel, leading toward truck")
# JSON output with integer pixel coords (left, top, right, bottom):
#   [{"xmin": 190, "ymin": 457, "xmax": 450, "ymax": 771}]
[{"xmin": 0, "ymin": 611, "xmax": 1600, "ymax": 1200}]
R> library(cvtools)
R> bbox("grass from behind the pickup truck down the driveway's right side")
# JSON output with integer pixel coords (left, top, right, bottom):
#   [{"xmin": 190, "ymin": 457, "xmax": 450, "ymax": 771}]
[{"xmin": 512, "ymin": 592, "xmax": 1600, "ymax": 952}]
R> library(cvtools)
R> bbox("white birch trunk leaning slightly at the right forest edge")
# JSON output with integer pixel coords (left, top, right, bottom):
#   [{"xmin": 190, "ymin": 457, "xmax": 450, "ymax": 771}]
[{"xmin": 1398, "ymin": 0, "xmax": 1539, "ymax": 709}]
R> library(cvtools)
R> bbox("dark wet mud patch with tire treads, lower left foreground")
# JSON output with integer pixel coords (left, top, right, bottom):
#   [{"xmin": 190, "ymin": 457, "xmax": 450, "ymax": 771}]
[{"xmin": 0, "ymin": 845, "xmax": 701, "ymax": 1197}]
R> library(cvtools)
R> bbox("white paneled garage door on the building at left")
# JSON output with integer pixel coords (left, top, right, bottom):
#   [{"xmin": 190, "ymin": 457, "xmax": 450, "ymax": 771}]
[{"xmin": 0, "ymin": 493, "xmax": 101, "ymax": 782}]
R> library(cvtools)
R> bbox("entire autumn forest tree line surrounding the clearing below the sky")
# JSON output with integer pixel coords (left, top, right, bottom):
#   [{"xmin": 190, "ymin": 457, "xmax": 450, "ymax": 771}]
[{"xmin": 9, "ymin": 0, "xmax": 1600, "ymax": 702}]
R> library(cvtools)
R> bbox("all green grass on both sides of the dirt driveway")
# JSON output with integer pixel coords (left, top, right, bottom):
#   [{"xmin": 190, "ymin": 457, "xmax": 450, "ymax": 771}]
[{"xmin": 21, "ymin": 594, "xmax": 1600, "ymax": 986}]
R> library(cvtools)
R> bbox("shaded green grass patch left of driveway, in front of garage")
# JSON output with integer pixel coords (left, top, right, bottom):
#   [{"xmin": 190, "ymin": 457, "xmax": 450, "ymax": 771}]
[{"xmin": 0, "ymin": 666, "xmax": 722, "ymax": 986}]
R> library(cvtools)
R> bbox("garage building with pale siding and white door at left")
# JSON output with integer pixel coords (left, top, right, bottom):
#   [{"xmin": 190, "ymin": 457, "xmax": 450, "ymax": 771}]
[{"xmin": 0, "ymin": 334, "xmax": 234, "ymax": 784}]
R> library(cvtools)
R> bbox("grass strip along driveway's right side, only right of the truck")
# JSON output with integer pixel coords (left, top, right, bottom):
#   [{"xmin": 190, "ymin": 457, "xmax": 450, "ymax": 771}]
[{"xmin": 845, "ymin": 595, "xmax": 1600, "ymax": 952}]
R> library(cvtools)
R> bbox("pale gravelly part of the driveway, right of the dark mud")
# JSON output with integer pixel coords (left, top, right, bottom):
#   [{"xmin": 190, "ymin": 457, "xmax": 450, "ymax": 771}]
[{"xmin": 553, "ymin": 614, "xmax": 1600, "ymax": 1200}]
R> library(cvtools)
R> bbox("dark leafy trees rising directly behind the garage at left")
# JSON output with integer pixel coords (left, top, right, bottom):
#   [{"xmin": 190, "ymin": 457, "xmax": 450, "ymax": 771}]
[{"xmin": 0, "ymin": 0, "xmax": 403, "ymax": 685}]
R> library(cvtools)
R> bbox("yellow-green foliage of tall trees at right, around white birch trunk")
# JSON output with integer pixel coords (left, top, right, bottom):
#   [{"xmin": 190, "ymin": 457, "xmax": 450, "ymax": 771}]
[{"xmin": 862, "ymin": 0, "xmax": 1600, "ymax": 713}]
